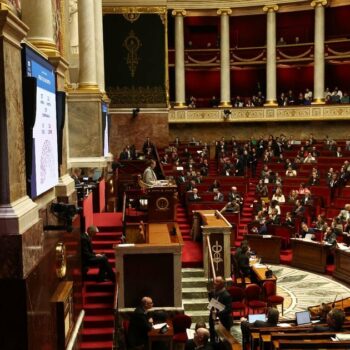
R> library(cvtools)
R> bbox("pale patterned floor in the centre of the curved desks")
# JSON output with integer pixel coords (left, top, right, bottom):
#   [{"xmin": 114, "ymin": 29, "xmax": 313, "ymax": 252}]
[{"xmin": 231, "ymin": 265, "xmax": 350, "ymax": 340}]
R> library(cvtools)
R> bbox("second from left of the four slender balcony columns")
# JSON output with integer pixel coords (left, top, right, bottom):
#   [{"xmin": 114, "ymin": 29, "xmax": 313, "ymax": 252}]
[{"xmin": 217, "ymin": 9, "xmax": 232, "ymax": 107}]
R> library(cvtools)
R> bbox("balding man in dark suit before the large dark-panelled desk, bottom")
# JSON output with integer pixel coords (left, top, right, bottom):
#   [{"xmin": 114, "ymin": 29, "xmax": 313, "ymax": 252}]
[{"xmin": 127, "ymin": 297, "xmax": 153, "ymax": 350}]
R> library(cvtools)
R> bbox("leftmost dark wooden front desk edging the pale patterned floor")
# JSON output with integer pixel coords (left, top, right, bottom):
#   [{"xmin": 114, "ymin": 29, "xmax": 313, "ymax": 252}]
[{"xmin": 244, "ymin": 234, "xmax": 281, "ymax": 264}]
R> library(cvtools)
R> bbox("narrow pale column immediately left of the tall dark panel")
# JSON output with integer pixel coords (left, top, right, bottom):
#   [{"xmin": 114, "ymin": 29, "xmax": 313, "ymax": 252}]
[{"xmin": 94, "ymin": 0, "xmax": 105, "ymax": 93}]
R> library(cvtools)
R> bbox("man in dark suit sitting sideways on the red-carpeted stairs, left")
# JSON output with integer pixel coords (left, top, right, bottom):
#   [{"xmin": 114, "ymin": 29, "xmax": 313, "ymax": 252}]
[{"xmin": 80, "ymin": 226, "xmax": 115, "ymax": 283}]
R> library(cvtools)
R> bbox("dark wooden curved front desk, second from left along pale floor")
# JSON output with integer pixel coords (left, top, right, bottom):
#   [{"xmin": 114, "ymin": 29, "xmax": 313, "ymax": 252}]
[{"xmin": 291, "ymin": 238, "xmax": 329, "ymax": 273}]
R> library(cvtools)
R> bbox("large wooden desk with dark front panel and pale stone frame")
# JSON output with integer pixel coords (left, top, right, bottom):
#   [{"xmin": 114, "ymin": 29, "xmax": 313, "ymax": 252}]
[{"xmin": 114, "ymin": 223, "xmax": 183, "ymax": 310}]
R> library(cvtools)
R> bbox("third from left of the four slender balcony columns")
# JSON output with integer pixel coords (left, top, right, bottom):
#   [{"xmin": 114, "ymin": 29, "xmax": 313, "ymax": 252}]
[{"xmin": 263, "ymin": 5, "xmax": 278, "ymax": 106}]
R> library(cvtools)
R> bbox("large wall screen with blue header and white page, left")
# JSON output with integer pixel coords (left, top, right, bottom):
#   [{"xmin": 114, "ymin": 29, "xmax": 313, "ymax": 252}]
[{"xmin": 23, "ymin": 45, "xmax": 58, "ymax": 197}]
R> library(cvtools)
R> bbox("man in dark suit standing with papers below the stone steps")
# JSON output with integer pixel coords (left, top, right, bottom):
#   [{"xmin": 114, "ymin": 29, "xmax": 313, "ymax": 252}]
[{"xmin": 208, "ymin": 276, "xmax": 233, "ymax": 342}]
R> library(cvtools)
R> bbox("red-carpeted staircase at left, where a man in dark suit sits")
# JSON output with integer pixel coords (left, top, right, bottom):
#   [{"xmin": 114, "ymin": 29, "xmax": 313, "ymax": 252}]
[{"xmin": 80, "ymin": 213, "xmax": 122, "ymax": 350}]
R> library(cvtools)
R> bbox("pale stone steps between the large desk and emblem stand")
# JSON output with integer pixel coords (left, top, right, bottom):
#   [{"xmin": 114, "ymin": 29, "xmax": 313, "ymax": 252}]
[{"xmin": 182, "ymin": 268, "xmax": 209, "ymax": 323}]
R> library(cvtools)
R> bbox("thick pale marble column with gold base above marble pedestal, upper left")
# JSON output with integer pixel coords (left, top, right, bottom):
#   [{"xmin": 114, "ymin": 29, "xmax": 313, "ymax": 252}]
[{"xmin": 78, "ymin": 0, "xmax": 98, "ymax": 91}]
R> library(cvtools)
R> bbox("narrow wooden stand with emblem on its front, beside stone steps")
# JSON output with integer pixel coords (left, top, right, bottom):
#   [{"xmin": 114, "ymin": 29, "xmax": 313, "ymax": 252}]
[{"xmin": 198, "ymin": 210, "xmax": 232, "ymax": 279}]
